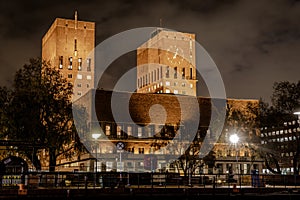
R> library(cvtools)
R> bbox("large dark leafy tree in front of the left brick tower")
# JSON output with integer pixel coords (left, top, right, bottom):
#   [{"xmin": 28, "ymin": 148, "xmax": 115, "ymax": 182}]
[{"xmin": 1, "ymin": 59, "xmax": 84, "ymax": 171}]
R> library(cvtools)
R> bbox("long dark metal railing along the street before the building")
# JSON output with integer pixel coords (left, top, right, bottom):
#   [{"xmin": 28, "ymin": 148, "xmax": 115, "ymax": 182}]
[{"xmin": 0, "ymin": 172, "xmax": 300, "ymax": 189}]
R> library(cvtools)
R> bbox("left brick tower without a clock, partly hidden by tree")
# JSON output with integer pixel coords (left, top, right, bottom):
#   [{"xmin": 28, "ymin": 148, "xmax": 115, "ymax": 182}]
[{"xmin": 42, "ymin": 12, "xmax": 95, "ymax": 101}]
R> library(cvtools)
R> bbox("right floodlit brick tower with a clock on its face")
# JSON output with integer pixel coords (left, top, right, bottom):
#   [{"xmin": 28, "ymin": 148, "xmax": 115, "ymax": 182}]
[{"xmin": 137, "ymin": 28, "xmax": 197, "ymax": 96}]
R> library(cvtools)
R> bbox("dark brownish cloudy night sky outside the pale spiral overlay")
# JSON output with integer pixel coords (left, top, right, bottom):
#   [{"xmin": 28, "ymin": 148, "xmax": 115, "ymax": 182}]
[{"xmin": 0, "ymin": 0, "xmax": 300, "ymax": 101}]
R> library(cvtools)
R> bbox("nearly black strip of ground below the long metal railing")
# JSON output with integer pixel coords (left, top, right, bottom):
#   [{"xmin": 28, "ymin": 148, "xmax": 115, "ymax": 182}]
[{"xmin": 0, "ymin": 188, "xmax": 300, "ymax": 200}]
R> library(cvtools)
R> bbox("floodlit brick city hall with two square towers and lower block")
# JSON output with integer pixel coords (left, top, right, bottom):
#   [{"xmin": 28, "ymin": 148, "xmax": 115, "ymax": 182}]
[{"xmin": 0, "ymin": 13, "xmax": 263, "ymax": 177}]
